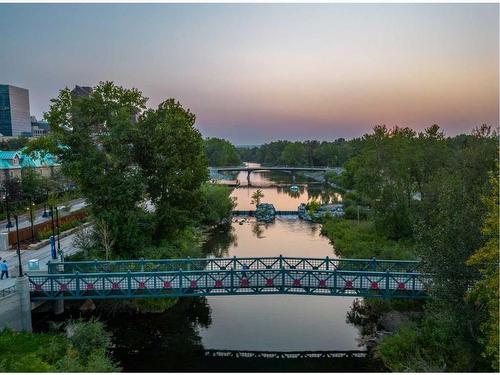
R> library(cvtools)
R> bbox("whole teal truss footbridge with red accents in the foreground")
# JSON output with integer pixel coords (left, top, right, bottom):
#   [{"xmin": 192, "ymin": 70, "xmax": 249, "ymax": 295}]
[{"xmin": 29, "ymin": 256, "xmax": 431, "ymax": 300}]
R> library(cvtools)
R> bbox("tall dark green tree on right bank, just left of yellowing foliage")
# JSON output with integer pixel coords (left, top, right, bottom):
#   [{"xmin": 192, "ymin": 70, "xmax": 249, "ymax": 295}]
[{"xmin": 416, "ymin": 125, "xmax": 497, "ymax": 309}]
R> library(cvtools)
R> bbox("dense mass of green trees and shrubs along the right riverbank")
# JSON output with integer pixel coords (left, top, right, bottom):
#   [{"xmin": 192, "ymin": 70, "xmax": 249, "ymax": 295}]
[{"xmin": 323, "ymin": 126, "xmax": 499, "ymax": 372}]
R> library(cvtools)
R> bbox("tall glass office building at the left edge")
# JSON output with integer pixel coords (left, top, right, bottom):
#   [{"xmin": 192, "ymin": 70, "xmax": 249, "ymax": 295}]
[{"xmin": 0, "ymin": 85, "xmax": 31, "ymax": 137}]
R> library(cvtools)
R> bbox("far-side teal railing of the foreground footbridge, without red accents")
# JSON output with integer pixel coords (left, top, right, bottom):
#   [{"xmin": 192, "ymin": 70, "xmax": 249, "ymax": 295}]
[{"xmin": 48, "ymin": 256, "xmax": 421, "ymax": 273}]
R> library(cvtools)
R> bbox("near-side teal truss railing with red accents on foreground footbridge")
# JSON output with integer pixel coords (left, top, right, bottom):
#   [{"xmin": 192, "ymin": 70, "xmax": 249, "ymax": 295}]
[{"xmin": 29, "ymin": 268, "xmax": 431, "ymax": 300}]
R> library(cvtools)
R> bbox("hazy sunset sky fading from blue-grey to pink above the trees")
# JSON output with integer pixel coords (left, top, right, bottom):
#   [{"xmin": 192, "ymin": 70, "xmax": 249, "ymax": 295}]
[{"xmin": 0, "ymin": 4, "xmax": 499, "ymax": 144}]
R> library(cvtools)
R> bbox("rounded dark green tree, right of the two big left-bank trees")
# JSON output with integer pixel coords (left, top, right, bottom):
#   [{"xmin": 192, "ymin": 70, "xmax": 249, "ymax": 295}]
[{"xmin": 132, "ymin": 99, "xmax": 208, "ymax": 241}]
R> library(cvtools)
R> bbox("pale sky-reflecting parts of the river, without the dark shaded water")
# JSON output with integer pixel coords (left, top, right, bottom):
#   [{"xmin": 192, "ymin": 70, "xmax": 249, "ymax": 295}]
[{"xmin": 196, "ymin": 167, "xmax": 363, "ymax": 351}]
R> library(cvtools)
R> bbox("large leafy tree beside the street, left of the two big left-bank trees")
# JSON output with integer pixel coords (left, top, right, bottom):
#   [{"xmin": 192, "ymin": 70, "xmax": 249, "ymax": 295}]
[{"xmin": 28, "ymin": 82, "xmax": 148, "ymax": 254}]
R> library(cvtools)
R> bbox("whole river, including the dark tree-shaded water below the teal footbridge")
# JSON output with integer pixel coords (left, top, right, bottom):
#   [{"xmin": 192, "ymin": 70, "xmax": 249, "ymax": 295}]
[{"xmin": 32, "ymin": 167, "xmax": 378, "ymax": 372}]
